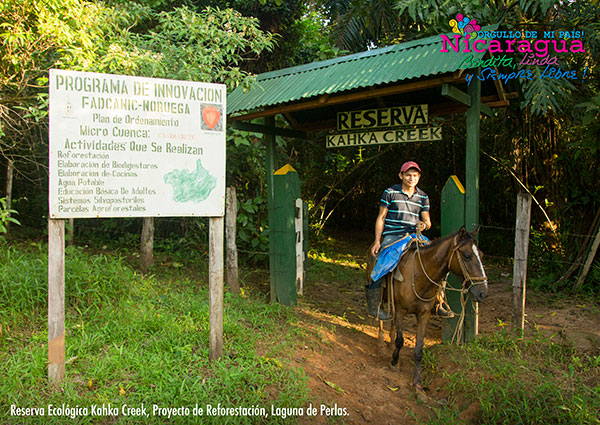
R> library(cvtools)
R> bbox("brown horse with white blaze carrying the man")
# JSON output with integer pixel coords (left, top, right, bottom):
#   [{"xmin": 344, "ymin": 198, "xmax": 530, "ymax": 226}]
[{"xmin": 367, "ymin": 226, "xmax": 487, "ymax": 390}]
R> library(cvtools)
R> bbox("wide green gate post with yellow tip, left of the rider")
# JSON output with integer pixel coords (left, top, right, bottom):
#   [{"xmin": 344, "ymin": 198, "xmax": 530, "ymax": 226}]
[{"xmin": 269, "ymin": 164, "xmax": 300, "ymax": 305}]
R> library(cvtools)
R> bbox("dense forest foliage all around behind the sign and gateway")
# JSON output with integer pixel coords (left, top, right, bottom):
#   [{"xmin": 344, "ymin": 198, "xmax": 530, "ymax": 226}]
[{"xmin": 0, "ymin": 0, "xmax": 600, "ymax": 292}]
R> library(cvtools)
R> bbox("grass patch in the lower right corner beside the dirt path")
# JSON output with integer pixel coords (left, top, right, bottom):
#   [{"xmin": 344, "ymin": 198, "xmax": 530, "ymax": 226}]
[{"xmin": 426, "ymin": 330, "xmax": 600, "ymax": 425}]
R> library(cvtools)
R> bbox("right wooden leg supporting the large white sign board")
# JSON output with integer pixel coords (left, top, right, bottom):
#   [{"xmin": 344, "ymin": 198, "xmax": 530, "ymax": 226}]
[{"xmin": 208, "ymin": 217, "xmax": 224, "ymax": 362}]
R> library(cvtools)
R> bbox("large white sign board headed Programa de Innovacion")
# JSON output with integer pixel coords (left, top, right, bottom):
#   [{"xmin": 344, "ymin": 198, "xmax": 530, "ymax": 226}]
[{"xmin": 49, "ymin": 69, "xmax": 226, "ymax": 218}]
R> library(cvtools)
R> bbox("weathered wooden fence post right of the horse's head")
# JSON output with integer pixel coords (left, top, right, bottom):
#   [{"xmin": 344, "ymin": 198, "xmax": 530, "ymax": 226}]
[{"xmin": 513, "ymin": 193, "xmax": 531, "ymax": 331}]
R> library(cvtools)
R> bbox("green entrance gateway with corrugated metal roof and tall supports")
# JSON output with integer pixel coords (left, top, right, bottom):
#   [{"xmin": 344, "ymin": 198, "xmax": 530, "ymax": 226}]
[{"xmin": 227, "ymin": 25, "xmax": 516, "ymax": 339}]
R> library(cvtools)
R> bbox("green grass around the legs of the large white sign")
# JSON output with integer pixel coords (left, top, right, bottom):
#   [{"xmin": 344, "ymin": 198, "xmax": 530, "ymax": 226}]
[{"xmin": 0, "ymin": 240, "xmax": 307, "ymax": 424}]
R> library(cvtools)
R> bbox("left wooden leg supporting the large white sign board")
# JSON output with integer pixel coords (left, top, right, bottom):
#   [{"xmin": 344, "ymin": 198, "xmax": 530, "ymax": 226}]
[{"xmin": 48, "ymin": 219, "xmax": 65, "ymax": 384}]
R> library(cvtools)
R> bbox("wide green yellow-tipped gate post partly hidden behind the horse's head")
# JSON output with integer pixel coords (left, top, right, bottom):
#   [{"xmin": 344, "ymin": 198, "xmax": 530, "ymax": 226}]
[{"xmin": 441, "ymin": 176, "xmax": 465, "ymax": 342}]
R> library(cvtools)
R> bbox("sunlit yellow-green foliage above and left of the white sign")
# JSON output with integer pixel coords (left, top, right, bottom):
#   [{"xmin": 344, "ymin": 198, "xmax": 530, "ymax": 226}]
[{"xmin": 0, "ymin": 0, "xmax": 273, "ymax": 171}]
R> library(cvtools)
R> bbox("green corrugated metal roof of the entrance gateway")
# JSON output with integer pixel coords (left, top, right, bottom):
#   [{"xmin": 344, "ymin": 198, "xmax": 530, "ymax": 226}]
[{"xmin": 227, "ymin": 25, "xmax": 498, "ymax": 114}]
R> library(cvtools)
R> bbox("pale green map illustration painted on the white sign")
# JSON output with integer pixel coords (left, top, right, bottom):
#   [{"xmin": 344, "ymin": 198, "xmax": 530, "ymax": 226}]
[{"xmin": 164, "ymin": 160, "xmax": 217, "ymax": 202}]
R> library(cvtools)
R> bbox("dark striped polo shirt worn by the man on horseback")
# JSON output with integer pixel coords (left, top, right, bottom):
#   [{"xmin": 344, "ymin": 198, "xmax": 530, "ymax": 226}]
[{"xmin": 380, "ymin": 184, "xmax": 429, "ymax": 236}]
